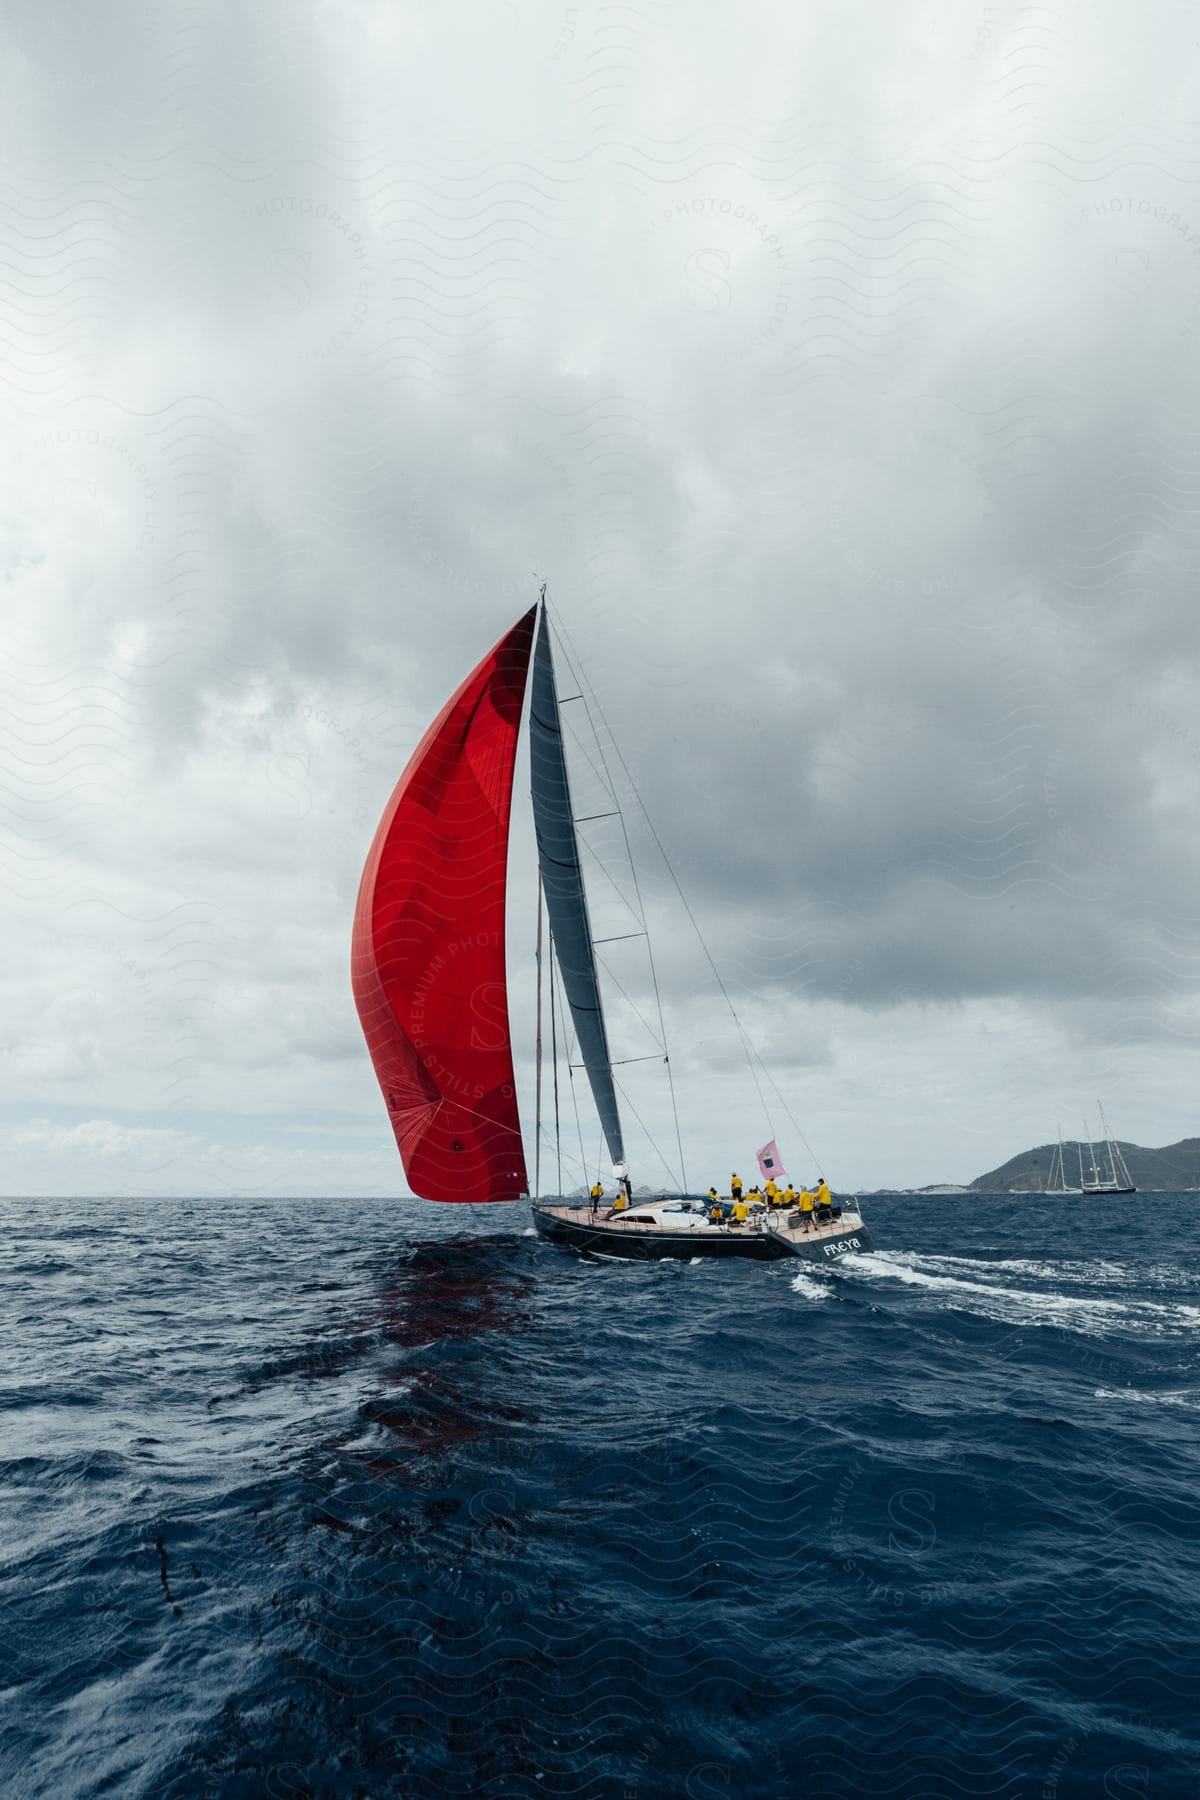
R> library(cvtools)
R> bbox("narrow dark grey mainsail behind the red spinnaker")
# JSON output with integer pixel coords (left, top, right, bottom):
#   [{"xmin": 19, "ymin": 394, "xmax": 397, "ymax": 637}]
[{"xmin": 529, "ymin": 608, "xmax": 624, "ymax": 1165}]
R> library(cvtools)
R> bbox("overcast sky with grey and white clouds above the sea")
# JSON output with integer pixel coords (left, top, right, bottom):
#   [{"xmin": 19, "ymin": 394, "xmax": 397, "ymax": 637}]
[{"xmin": 0, "ymin": 0, "xmax": 1200, "ymax": 1195}]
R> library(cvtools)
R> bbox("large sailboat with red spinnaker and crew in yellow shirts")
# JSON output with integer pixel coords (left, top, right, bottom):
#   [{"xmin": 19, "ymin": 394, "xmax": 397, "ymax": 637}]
[{"xmin": 351, "ymin": 589, "xmax": 871, "ymax": 1262}]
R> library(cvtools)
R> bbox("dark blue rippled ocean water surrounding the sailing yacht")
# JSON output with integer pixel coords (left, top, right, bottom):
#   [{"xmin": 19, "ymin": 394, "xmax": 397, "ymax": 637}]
[{"xmin": 0, "ymin": 1195, "xmax": 1200, "ymax": 1800}]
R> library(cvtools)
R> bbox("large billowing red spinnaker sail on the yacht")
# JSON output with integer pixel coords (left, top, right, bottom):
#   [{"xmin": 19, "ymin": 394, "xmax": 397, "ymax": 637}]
[{"xmin": 351, "ymin": 607, "xmax": 536, "ymax": 1201}]
